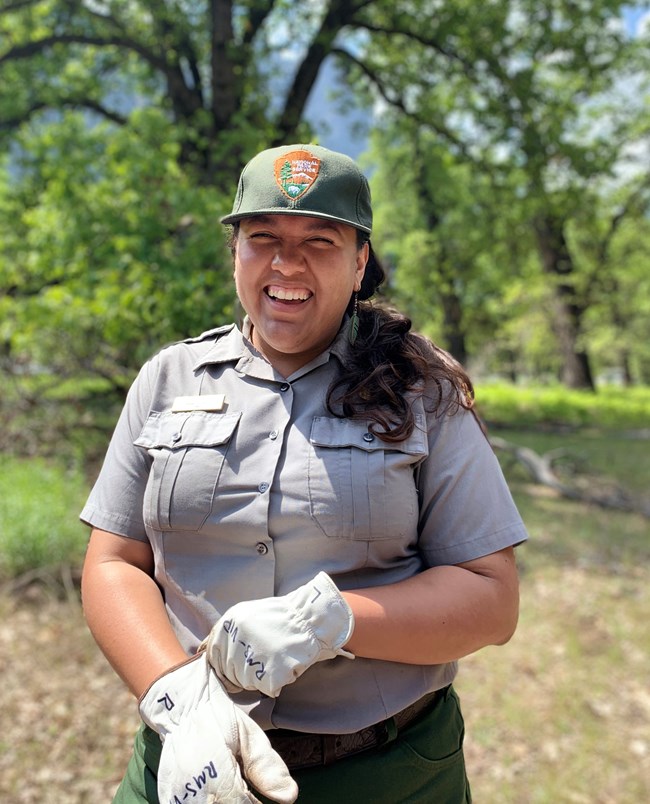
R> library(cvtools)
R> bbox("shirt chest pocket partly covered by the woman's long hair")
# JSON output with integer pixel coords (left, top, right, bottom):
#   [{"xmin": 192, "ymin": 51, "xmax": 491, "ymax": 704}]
[{"xmin": 308, "ymin": 415, "xmax": 428, "ymax": 541}]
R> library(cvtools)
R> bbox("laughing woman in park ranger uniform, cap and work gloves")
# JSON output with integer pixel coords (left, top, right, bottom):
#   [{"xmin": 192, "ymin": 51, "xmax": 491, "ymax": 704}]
[{"xmin": 82, "ymin": 145, "xmax": 526, "ymax": 804}]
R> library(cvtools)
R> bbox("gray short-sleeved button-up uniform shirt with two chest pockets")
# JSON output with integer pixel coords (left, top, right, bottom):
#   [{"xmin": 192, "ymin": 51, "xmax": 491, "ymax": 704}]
[{"xmin": 81, "ymin": 325, "xmax": 526, "ymax": 733}]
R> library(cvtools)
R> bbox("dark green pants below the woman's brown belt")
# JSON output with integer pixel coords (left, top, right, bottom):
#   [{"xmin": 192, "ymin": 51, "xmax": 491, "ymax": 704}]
[{"xmin": 113, "ymin": 687, "xmax": 472, "ymax": 804}]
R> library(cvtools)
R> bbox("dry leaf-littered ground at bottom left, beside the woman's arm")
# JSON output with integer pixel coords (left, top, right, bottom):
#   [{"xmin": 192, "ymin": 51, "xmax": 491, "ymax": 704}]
[{"xmin": 0, "ymin": 587, "xmax": 138, "ymax": 804}]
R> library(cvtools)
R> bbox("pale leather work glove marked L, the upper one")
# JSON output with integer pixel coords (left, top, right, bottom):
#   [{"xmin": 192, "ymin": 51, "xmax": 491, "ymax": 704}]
[{"xmin": 199, "ymin": 572, "xmax": 354, "ymax": 698}]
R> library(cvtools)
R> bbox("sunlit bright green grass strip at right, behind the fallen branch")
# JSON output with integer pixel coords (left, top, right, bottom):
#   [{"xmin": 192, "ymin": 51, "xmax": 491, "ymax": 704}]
[{"xmin": 476, "ymin": 383, "xmax": 650, "ymax": 430}]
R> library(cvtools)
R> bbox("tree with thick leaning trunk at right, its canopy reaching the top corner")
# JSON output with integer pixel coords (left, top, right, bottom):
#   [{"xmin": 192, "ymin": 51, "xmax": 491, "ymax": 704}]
[{"xmin": 344, "ymin": 0, "xmax": 650, "ymax": 388}]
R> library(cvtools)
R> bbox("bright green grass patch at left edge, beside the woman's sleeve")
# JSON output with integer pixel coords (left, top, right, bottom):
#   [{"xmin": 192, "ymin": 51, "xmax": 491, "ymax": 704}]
[{"xmin": 0, "ymin": 456, "xmax": 88, "ymax": 578}]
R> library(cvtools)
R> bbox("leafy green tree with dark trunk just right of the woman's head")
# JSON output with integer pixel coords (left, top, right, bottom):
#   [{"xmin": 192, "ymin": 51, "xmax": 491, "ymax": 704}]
[{"xmin": 368, "ymin": 118, "xmax": 531, "ymax": 372}]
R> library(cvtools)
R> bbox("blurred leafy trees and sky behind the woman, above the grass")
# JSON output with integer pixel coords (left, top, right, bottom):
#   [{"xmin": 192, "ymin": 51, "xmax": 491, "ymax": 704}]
[{"xmin": 0, "ymin": 0, "xmax": 650, "ymax": 458}]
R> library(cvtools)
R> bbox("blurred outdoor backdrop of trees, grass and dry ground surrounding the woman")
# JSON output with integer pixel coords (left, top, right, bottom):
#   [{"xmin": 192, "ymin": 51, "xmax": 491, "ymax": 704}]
[{"xmin": 0, "ymin": 0, "xmax": 650, "ymax": 804}]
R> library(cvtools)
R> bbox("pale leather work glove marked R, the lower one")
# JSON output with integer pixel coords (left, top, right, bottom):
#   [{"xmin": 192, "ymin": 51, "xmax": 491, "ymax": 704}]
[{"xmin": 140, "ymin": 654, "xmax": 298, "ymax": 804}]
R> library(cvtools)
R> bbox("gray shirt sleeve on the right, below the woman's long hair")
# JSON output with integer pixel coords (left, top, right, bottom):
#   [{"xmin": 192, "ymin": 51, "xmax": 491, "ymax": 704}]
[{"xmin": 416, "ymin": 400, "xmax": 528, "ymax": 567}]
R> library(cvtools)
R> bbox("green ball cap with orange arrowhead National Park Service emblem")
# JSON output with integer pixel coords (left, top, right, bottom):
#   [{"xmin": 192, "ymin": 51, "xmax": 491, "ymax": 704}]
[{"xmin": 221, "ymin": 145, "xmax": 372, "ymax": 234}]
